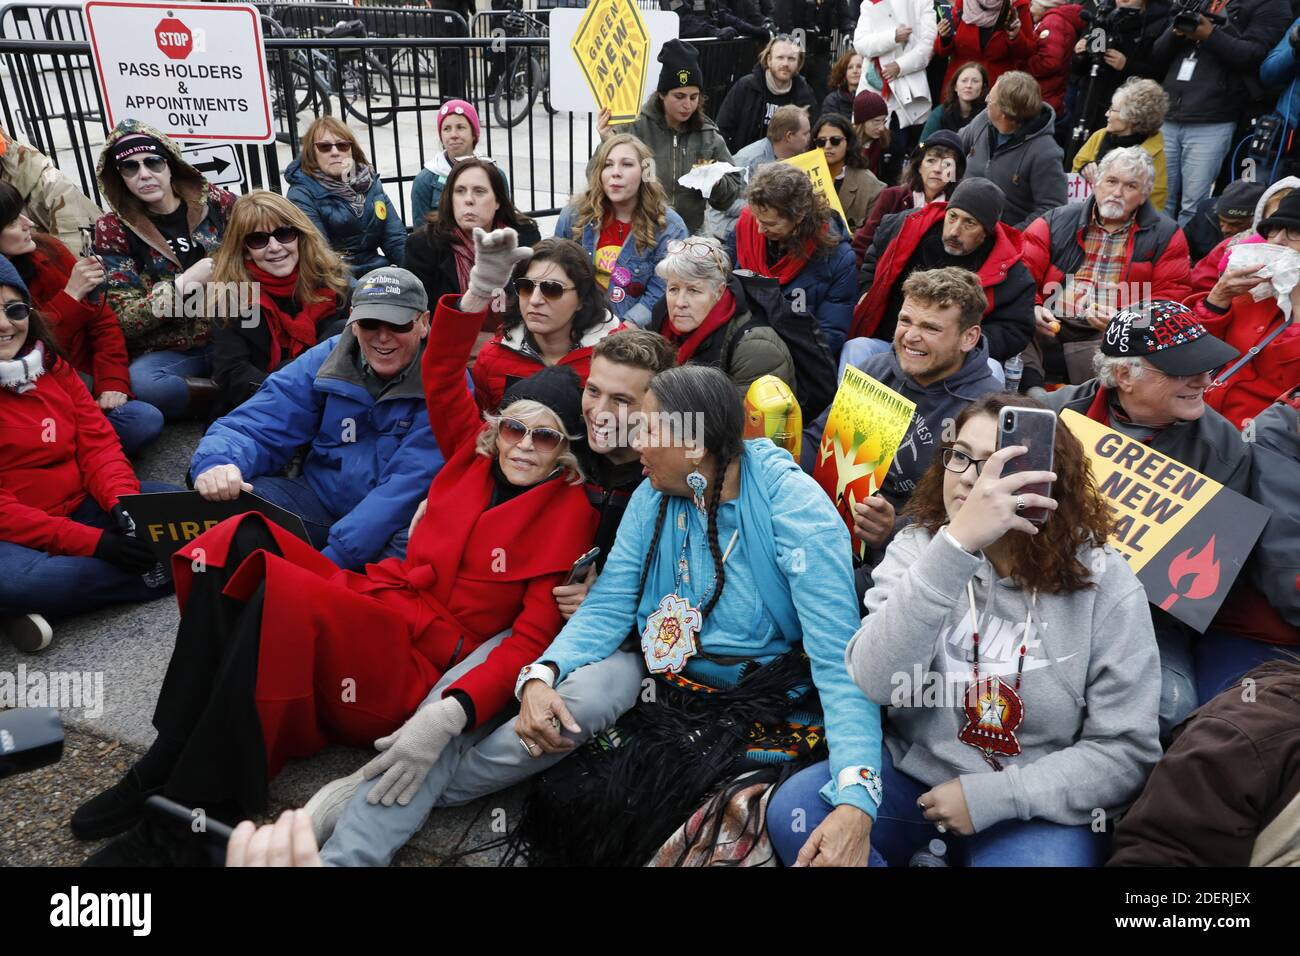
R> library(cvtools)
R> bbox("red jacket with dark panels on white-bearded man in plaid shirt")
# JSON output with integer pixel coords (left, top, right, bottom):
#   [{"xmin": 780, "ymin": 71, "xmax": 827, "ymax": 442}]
[{"xmin": 1024, "ymin": 196, "xmax": 1191, "ymax": 306}]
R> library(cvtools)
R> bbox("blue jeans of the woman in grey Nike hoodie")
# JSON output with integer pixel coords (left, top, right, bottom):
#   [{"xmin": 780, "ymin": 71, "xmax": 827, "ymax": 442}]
[{"xmin": 767, "ymin": 748, "xmax": 1109, "ymax": 866}]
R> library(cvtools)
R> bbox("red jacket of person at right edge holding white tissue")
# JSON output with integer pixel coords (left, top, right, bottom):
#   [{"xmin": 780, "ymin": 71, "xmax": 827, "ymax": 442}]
[{"xmin": 1187, "ymin": 293, "xmax": 1300, "ymax": 428}]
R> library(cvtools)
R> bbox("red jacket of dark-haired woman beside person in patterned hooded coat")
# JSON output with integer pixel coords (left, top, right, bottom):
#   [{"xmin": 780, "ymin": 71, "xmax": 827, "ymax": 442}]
[{"xmin": 27, "ymin": 242, "xmax": 131, "ymax": 395}]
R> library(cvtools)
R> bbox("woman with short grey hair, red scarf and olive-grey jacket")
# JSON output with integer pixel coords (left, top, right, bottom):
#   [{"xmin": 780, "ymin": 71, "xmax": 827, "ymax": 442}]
[{"xmin": 650, "ymin": 237, "xmax": 796, "ymax": 398}]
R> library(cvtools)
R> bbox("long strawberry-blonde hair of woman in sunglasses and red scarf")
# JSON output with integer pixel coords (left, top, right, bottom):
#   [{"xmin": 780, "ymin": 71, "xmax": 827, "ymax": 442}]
[{"xmin": 212, "ymin": 189, "xmax": 347, "ymax": 323}]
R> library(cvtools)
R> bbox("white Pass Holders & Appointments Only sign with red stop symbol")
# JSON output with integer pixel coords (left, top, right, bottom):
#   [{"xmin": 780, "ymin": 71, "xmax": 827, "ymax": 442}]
[{"xmin": 86, "ymin": 0, "xmax": 276, "ymax": 143}]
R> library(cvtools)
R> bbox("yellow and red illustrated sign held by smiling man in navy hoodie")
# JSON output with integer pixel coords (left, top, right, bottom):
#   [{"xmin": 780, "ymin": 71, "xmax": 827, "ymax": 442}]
[{"xmin": 813, "ymin": 365, "xmax": 917, "ymax": 554}]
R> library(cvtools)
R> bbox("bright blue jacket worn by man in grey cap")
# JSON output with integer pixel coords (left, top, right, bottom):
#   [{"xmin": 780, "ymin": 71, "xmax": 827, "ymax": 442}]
[{"xmin": 190, "ymin": 329, "xmax": 454, "ymax": 570}]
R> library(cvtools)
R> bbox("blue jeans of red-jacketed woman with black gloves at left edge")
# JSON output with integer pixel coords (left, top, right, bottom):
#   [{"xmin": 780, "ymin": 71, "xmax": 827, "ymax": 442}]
[{"xmin": 0, "ymin": 481, "xmax": 182, "ymax": 618}]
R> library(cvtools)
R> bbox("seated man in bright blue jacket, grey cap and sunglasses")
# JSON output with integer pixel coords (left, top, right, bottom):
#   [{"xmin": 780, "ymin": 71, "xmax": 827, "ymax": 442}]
[{"xmin": 190, "ymin": 267, "xmax": 443, "ymax": 570}]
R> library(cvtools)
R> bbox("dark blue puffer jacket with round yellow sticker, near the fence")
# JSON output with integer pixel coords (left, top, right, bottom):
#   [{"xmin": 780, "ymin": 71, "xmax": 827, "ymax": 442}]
[{"xmin": 285, "ymin": 160, "xmax": 406, "ymax": 278}]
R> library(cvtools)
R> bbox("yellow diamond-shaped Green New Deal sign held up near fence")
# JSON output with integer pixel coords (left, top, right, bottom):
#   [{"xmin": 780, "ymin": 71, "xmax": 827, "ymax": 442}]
[{"xmin": 569, "ymin": 0, "xmax": 650, "ymax": 124}]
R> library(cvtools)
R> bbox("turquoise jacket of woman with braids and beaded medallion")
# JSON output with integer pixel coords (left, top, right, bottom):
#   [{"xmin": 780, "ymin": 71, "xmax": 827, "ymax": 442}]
[{"xmin": 541, "ymin": 438, "xmax": 880, "ymax": 817}]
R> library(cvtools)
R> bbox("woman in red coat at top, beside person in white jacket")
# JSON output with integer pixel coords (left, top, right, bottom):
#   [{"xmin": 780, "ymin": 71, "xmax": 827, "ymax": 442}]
[{"xmin": 935, "ymin": 0, "xmax": 1037, "ymax": 88}]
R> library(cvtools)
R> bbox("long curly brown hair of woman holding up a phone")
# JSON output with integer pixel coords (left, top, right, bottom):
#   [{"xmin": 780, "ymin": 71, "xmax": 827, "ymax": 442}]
[{"xmin": 902, "ymin": 392, "xmax": 1114, "ymax": 594}]
